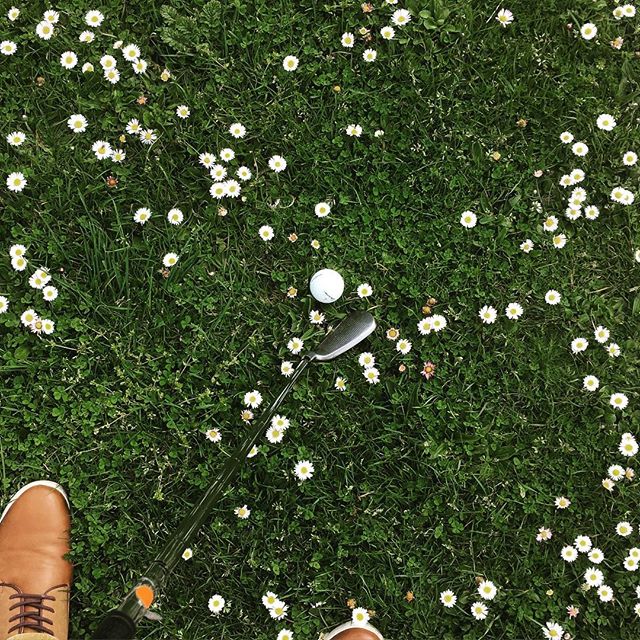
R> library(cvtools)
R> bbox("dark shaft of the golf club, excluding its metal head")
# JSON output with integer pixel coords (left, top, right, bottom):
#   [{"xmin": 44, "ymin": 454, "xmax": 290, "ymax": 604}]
[{"xmin": 96, "ymin": 356, "xmax": 312, "ymax": 640}]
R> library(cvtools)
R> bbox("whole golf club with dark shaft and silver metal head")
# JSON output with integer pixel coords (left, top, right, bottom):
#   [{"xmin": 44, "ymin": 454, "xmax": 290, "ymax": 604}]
[{"xmin": 94, "ymin": 311, "xmax": 376, "ymax": 640}]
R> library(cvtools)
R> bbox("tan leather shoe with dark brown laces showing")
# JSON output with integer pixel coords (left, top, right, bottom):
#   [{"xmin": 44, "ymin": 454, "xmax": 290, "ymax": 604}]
[{"xmin": 0, "ymin": 480, "xmax": 73, "ymax": 640}]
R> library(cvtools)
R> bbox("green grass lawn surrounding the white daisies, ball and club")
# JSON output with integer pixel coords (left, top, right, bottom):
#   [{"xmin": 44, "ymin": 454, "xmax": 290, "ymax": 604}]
[{"xmin": 0, "ymin": 0, "xmax": 640, "ymax": 640}]
